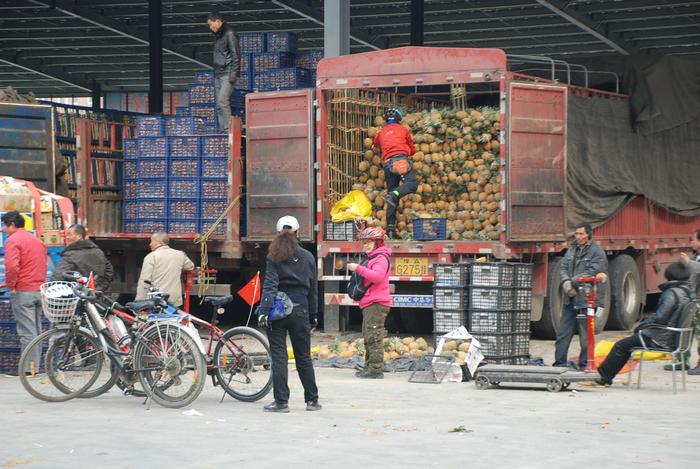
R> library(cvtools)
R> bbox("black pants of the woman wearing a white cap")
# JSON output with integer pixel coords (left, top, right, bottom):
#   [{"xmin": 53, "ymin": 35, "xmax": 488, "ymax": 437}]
[{"xmin": 267, "ymin": 308, "xmax": 318, "ymax": 404}]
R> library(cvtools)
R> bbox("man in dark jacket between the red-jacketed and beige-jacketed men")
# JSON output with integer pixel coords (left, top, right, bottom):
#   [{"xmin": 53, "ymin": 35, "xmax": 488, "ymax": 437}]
[{"xmin": 53, "ymin": 224, "xmax": 114, "ymax": 292}]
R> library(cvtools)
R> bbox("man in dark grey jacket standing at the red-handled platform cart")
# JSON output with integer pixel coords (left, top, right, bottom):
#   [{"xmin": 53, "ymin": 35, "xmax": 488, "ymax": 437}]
[{"xmin": 554, "ymin": 223, "xmax": 608, "ymax": 370}]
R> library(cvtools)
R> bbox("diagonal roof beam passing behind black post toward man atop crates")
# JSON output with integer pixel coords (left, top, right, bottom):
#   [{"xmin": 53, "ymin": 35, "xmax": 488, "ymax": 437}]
[{"xmin": 27, "ymin": 0, "xmax": 211, "ymax": 68}]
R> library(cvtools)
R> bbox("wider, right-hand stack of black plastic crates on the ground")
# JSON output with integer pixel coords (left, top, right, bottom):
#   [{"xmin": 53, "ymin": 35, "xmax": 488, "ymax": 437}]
[{"xmin": 466, "ymin": 262, "xmax": 532, "ymax": 365}]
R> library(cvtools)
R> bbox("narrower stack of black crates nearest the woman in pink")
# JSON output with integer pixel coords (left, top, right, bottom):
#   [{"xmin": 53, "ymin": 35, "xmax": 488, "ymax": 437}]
[{"xmin": 433, "ymin": 264, "xmax": 469, "ymax": 334}]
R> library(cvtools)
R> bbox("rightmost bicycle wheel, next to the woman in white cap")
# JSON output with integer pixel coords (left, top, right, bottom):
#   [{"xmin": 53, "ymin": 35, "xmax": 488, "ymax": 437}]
[{"xmin": 212, "ymin": 327, "xmax": 272, "ymax": 402}]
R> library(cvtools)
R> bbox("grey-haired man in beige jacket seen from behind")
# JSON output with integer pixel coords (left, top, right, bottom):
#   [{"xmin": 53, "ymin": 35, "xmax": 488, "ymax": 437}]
[{"xmin": 136, "ymin": 232, "xmax": 194, "ymax": 307}]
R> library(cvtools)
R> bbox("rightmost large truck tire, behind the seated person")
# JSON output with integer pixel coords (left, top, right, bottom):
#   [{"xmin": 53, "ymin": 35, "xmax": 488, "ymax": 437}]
[{"xmin": 608, "ymin": 254, "xmax": 644, "ymax": 330}]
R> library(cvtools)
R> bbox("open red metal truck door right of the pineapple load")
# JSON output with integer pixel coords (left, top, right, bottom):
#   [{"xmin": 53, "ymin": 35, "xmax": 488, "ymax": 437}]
[{"xmin": 507, "ymin": 83, "xmax": 567, "ymax": 241}]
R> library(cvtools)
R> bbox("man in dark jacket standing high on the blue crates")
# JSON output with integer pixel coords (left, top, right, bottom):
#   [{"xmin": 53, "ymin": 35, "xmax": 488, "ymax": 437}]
[{"xmin": 207, "ymin": 12, "xmax": 241, "ymax": 132}]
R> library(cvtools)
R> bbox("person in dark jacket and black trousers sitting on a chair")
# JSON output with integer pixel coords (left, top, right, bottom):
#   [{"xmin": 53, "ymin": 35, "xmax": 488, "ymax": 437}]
[{"xmin": 596, "ymin": 262, "xmax": 692, "ymax": 386}]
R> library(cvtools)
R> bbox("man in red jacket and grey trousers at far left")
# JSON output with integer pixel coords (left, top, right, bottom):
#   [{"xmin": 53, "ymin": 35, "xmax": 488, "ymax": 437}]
[{"xmin": 2, "ymin": 210, "xmax": 47, "ymax": 371}]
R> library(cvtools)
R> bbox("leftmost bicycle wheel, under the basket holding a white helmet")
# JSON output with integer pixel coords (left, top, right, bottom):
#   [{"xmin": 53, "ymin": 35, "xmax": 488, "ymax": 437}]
[{"xmin": 19, "ymin": 326, "xmax": 103, "ymax": 402}]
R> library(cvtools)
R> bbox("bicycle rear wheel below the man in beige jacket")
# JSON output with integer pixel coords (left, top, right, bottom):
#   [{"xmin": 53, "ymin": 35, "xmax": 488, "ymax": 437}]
[{"xmin": 134, "ymin": 322, "xmax": 207, "ymax": 407}]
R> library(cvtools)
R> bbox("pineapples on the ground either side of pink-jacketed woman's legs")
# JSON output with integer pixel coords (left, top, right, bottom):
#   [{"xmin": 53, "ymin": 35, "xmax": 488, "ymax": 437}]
[{"xmin": 311, "ymin": 337, "xmax": 434, "ymax": 361}]
